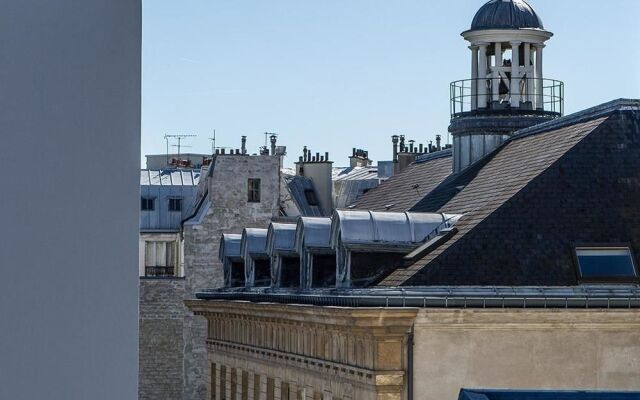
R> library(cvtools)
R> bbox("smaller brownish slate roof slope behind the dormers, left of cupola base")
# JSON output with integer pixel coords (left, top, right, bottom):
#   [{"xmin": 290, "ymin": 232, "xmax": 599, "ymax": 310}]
[{"xmin": 354, "ymin": 150, "xmax": 453, "ymax": 211}]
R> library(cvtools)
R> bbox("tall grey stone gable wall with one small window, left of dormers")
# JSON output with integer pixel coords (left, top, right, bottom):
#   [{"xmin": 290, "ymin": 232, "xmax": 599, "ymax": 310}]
[{"xmin": 184, "ymin": 155, "xmax": 281, "ymax": 400}]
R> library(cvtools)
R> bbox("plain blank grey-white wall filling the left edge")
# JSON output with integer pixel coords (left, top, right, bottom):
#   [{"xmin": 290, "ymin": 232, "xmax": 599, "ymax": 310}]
[{"xmin": 0, "ymin": 0, "xmax": 141, "ymax": 400}]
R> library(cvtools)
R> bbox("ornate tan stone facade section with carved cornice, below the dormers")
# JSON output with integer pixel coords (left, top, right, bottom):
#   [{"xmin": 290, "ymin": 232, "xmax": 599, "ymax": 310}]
[{"xmin": 187, "ymin": 300, "xmax": 417, "ymax": 400}]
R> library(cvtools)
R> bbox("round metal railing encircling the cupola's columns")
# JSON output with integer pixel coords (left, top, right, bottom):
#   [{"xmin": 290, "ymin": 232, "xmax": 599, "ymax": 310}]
[{"xmin": 451, "ymin": 77, "xmax": 564, "ymax": 118}]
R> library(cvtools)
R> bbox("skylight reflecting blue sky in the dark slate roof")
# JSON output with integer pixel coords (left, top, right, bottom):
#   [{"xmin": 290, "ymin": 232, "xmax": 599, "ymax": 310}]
[{"xmin": 576, "ymin": 247, "xmax": 638, "ymax": 281}]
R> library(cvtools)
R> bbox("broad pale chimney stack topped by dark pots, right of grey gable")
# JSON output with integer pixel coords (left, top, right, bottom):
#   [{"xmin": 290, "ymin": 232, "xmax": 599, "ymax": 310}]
[{"xmin": 296, "ymin": 146, "xmax": 333, "ymax": 216}]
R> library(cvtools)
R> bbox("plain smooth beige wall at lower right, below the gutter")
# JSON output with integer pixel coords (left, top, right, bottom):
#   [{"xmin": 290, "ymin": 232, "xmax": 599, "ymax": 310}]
[{"xmin": 413, "ymin": 309, "xmax": 640, "ymax": 400}]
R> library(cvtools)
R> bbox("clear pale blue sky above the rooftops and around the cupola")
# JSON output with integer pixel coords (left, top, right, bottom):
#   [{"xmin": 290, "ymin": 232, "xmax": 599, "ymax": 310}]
[{"xmin": 142, "ymin": 0, "xmax": 640, "ymax": 166}]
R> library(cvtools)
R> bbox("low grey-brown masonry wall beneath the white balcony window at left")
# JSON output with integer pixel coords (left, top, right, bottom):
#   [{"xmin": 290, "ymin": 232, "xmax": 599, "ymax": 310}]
[{"xmin": 138, "ymin": 278, "xmax": 186, "ymax": 400}]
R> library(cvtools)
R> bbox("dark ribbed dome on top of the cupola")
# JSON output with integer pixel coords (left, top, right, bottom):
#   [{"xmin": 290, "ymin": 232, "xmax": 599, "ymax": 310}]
[{"xmin": 471, "ymin": 0, "xmax": 544, "ymax": 31}]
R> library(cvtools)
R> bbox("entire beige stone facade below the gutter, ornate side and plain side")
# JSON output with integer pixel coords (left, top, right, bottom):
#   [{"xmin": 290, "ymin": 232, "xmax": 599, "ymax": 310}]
[{"xmin": 188, "ymin": 300, "xmax": 640, "ymax": 400}]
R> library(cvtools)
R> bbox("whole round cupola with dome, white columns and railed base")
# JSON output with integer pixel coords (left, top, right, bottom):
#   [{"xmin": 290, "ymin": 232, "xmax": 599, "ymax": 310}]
[{"xmin": 449, "ymin": 0, "xmax": 564, "ymax": 172}]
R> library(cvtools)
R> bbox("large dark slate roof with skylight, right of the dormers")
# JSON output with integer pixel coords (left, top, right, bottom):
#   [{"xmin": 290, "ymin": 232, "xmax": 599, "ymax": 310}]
[{"xmin": 380, "ymin": 100, "xmax": 640, "ymax": 286}]
